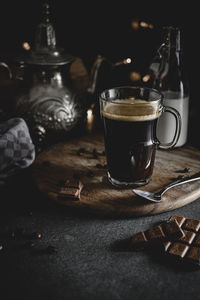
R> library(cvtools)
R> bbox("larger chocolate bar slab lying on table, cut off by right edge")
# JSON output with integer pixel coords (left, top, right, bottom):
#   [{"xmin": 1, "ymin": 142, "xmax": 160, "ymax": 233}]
[{"xmin": 163, "ymin": 216, "xmax": 200, "ymax": 266}]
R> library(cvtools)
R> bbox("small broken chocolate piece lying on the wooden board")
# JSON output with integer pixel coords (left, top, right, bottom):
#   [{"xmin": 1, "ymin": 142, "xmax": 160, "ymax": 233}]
[{"xmin": 58, "ymin": 179, "xmax": 83, "ymax": 201}]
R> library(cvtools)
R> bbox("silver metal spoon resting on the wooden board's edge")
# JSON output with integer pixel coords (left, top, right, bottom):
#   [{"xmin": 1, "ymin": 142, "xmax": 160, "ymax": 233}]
[{"xmin": 132, "ymin": 172, "xmax": 200, "ymax": 202}]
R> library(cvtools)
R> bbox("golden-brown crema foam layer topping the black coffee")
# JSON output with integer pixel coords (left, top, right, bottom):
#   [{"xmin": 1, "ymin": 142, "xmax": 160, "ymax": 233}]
[{"xmin": 101, "ymin": 99, "xmax": 162, "ymax": 122}]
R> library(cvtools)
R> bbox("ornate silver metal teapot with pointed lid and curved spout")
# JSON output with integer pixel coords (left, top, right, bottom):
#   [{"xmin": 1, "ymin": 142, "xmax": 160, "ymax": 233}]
[{"xmin": 0, "ymin": 5, "xmax": 132, "ymax": 143}]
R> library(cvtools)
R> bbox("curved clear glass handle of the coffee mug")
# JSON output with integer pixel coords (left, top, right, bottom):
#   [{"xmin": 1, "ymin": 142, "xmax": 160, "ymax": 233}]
[{"xmin": 158, "ymin": 106, "xmax": 181, "ymax": 149}]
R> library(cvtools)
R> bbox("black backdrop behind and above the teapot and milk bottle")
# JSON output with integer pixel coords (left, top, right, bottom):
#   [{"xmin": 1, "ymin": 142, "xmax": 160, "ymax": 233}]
[{"xmin": 0, "ymin": 0, "xmax": 200, "ymax": 146}]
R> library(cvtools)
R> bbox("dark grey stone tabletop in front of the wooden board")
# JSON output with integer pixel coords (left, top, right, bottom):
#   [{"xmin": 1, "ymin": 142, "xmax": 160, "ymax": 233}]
[{"xmin": 0, "ymin": 170, "xmax": 200, "ymax": 300}]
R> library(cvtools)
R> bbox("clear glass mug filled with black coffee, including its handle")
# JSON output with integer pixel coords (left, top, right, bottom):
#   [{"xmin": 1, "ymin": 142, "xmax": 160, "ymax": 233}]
[{"xmin": 99, "ymin": 86, "xmax": 181, "ymax": 188}]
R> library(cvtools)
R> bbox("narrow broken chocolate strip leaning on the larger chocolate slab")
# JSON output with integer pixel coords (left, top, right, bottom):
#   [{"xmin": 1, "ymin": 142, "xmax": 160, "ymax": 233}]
[{"xmin": 131, "ymin": 218, "xmax": 185, "ymax": 250}]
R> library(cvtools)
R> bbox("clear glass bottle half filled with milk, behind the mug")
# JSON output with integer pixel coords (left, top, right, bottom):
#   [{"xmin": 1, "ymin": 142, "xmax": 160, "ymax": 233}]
[{"xmin": 149, "ymin": 26, "xmax": 189, "ymax": 147}]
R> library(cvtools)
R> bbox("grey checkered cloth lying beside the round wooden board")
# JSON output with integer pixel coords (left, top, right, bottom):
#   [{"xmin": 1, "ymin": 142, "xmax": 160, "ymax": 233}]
[{"xmin": 0, "ymin": 118, "xmax": 35, "ymax": 185}]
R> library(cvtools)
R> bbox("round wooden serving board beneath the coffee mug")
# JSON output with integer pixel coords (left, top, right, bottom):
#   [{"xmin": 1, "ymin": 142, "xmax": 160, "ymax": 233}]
[{"xmin": 32, "ymin": 135, "xmax": 200, "ymax": 217}]
